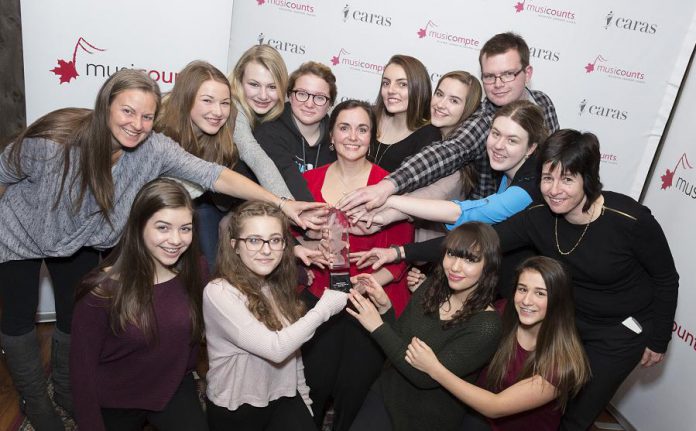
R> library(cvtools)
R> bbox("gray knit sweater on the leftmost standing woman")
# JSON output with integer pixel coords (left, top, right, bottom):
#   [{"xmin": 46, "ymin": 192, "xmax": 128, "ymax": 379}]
[{"xmin": 0, "ymin": 133, "xmax": 223, "ymax": 262}]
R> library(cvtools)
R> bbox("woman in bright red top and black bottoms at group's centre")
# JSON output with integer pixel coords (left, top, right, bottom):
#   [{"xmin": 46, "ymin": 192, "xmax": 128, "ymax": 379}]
[{"xmin": 303, "ymin": 100, "xmax": 413, "ymax": 430}]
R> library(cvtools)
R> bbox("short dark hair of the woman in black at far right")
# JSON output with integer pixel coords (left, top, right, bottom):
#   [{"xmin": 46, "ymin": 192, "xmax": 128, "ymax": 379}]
[{"xmin": 537, "ymin": 129, "xmax": 602, "ymax": 211}]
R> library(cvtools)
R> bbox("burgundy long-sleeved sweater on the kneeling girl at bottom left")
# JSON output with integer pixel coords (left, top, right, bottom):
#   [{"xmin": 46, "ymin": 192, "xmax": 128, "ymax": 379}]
[{"xmin": 70, "ymin": 277, "xmax": 199, "ymax": 431}]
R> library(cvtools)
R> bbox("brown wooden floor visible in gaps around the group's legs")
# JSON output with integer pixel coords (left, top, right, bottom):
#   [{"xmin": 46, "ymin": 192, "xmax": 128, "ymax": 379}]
[{"xmin": 0, "ymin": 323, "xmax": 617, "ymax": 431}]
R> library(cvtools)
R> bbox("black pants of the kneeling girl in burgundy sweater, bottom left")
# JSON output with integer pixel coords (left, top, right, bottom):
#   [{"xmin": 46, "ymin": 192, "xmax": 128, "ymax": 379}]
[{"xmin": 101, "ymin": 373, "xmax": 208, "ymax": 431}]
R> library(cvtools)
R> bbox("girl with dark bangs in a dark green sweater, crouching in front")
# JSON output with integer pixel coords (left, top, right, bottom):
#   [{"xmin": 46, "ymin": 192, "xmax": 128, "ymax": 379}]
[{"xmin": 347, "ymin": 222, "xmax": 501, "ymax": 431}]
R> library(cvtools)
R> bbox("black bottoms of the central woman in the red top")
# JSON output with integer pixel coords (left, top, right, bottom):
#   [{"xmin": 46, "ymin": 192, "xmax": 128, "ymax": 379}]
[{"xmin": 302, "ymin": 291, "xmax": 385, "ymax": 431}]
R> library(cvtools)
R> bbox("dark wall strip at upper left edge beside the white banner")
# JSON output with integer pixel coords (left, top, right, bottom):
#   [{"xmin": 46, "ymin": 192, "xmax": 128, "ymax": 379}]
[{"xmin": 0, "ymin": 0, "xmax": 26, "ymax": 143}]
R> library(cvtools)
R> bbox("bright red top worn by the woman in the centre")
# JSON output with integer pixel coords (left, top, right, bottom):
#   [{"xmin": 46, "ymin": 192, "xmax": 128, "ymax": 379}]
[{"xmin": 303, "ymin": 164, "xmax": 414, "ymax": 316}]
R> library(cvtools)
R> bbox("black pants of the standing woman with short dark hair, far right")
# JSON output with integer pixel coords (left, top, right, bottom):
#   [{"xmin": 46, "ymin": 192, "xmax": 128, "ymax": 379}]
[{"xmin": 560, "ymin": 320, "xmax": 652, "ymax": 431}]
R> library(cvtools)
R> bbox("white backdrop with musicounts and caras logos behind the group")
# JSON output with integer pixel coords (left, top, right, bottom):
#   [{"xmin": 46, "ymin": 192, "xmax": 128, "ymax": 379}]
[{"xmin": 21, "ymin": 0, "xmax": 696, "ymax": 430}]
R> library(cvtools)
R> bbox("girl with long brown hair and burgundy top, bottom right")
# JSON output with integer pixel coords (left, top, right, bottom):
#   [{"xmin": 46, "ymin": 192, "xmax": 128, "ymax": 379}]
[{"xmin": 406, "ymin": 256, "xmax": 590, "ymax": 431}]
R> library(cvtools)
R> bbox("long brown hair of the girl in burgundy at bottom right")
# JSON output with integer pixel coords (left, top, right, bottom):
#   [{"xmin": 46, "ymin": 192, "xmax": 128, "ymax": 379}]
[{"xmin": 488, "ymin": 256, "xmax": 590, "ymax": 410}]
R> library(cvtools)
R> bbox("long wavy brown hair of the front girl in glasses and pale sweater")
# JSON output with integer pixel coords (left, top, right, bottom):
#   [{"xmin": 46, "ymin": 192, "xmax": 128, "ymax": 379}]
[{"xmin": 216, "ymin": 201, "xmax": 304, "ymax": 331}]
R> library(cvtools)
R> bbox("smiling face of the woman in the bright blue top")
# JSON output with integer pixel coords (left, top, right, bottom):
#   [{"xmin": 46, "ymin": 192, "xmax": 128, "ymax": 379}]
[{"xmin": 486, "ymin": 117, "xmax": 536, "ymax": 178}]
